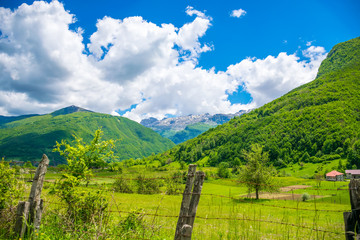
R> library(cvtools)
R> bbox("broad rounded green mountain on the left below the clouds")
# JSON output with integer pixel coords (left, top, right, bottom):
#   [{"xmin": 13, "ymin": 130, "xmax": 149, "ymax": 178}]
[{"xmin": 0, "ymin": 106, "xmax": 174, "ymax": 165}]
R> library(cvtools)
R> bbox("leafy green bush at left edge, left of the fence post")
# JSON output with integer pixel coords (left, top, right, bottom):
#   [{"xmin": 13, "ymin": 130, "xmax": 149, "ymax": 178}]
[{"xmin": 0, "ymin": 158, "xmax": 23, "ymax": 211}]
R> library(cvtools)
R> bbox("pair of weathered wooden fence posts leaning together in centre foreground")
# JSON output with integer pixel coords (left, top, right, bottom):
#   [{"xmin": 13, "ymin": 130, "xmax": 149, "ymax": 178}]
[{"xmin": 175, "ymin": 165, "xmax": 205, "ymax": 240}]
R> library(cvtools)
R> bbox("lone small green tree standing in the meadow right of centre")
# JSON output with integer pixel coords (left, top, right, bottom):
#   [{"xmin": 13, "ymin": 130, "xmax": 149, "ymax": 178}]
[{"xmin": 239, "ymin": 144, "xmax": 278, "ymax": 199}]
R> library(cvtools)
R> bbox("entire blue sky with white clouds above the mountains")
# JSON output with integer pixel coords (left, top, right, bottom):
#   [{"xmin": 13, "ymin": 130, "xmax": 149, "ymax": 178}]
[{"xmin": 0, "ymin": 0, "xmax": 360, "ymax": 121}]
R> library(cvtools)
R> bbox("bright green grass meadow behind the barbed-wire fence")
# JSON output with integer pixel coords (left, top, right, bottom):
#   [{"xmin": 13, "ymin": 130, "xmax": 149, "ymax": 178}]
[{"xmin": 19, "ymin": 167, "xmax": 350, "ymax": 239}]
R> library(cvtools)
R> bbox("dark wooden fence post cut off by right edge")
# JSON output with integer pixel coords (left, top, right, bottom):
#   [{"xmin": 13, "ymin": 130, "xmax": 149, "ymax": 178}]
[{"xmin": 343, "ymin": 179, "xmax": 360, "ymax": 240}]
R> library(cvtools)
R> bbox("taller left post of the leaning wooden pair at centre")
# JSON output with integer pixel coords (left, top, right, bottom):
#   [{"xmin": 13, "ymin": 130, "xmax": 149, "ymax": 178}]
[{"xmin": 175, "ymin": 164, "xmax": 196, "ymax": 240}]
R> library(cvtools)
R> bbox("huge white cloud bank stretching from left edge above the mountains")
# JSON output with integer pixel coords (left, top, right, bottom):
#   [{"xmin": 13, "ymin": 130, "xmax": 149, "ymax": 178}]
[{"xmin": 0, "ymin": 1, "xmax": 324, "ymax": 121}]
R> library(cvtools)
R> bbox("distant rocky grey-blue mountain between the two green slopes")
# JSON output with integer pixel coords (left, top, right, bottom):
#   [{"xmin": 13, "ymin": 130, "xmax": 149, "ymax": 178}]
[{"xmin": 140, "ymin": 111, "xmax": 249, "ymax": 144}]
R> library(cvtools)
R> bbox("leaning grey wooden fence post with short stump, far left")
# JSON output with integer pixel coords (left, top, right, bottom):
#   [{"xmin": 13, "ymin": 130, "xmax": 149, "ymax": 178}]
[{"xmin": 15, "ymin": 154, "xmax": 49, "ymax": 238}]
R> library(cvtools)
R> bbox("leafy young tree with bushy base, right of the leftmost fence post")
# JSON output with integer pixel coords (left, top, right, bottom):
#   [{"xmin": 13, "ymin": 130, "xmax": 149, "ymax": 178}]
[{"xmin": 52, "ymin": 130, "xmax": 114, "ymax": 228}]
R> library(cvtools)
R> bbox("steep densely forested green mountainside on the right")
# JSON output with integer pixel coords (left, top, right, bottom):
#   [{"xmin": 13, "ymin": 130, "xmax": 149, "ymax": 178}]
[{"xmin": 148, "ymin": 38, "xmax": 360, "ymax": 168}]
